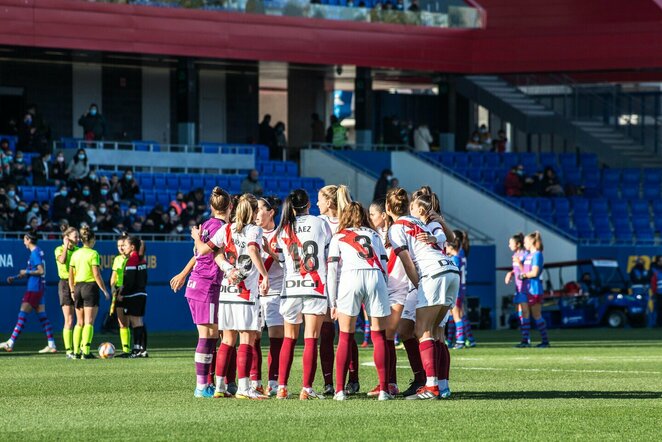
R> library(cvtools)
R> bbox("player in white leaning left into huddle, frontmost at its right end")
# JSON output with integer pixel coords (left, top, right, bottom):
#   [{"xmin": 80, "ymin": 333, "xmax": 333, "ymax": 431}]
[{"xmin": 386, "ymin": 188, "xmax": 459, "ymax": 399}]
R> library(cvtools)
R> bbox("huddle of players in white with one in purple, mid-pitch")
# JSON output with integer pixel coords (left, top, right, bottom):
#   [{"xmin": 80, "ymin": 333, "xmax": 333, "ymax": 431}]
[{"xmin": 171, "ymin": 186, "xmax": 464, "ymax": 400}]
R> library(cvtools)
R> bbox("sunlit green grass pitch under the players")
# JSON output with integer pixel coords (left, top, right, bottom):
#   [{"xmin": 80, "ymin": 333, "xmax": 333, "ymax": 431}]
[{"xmin": 0, "ymin": 329, "xmax": 662, "ymax": 441}]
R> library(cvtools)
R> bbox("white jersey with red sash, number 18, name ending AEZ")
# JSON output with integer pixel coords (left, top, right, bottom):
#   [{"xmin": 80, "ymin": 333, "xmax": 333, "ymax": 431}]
[{"xmin": 277, "ymin": 215, "xmax": 331, "ymax": 298}]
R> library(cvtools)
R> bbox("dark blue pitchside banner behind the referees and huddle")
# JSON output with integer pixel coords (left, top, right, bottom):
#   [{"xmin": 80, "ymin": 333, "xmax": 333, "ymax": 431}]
[{"xmin": 0, "ymin": 240, "xmax": 496, "ymax": 332}]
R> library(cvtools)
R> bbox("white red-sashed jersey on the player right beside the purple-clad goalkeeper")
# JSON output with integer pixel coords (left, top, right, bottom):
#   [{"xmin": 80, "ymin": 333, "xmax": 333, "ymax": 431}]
[{"xmin": 211, "ymin": 224, "xmax": 262, "ymax": 304}]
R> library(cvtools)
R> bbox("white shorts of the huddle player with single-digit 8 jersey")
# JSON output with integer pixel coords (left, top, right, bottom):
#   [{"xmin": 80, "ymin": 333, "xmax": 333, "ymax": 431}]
[{"xmin": 336, "ymin": 270, "xmax": 391, "ymax": 318}]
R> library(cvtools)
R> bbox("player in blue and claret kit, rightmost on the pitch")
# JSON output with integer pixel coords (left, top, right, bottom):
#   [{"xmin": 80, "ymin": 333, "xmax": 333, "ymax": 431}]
[{"xmin": 519, "ymin": 231, "xmax": 549, "ymax": 348}]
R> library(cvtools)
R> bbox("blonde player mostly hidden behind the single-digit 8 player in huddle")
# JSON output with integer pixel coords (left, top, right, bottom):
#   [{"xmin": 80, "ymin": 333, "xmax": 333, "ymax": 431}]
[{"xmin": 317, "ymin": 185, "xmax": 360, "ymax": 394}]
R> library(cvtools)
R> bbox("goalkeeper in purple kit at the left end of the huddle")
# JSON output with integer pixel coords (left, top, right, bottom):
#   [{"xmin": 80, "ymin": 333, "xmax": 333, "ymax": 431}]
[{"xmin": 170, "ymin": 187, "xmax": 234, "ymax": 398}]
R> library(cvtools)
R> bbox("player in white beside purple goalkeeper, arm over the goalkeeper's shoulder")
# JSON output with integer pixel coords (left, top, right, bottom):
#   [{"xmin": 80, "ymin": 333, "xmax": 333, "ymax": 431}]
[{"xmin": 192, "ymin": 194, "xmax": 269, "ymax": 399}]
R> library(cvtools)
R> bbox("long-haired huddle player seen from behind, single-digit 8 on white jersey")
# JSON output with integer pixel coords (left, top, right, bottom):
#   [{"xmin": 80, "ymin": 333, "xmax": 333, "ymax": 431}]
[{"xmin": 327, "ymin": 202, "xmax": 394, "ymax": 401}]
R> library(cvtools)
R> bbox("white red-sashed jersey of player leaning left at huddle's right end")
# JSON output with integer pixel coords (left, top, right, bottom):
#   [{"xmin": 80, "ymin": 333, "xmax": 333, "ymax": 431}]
[{"xmin": 388, "ymin": 216, "xmax": 459, "ymax": 277}]
